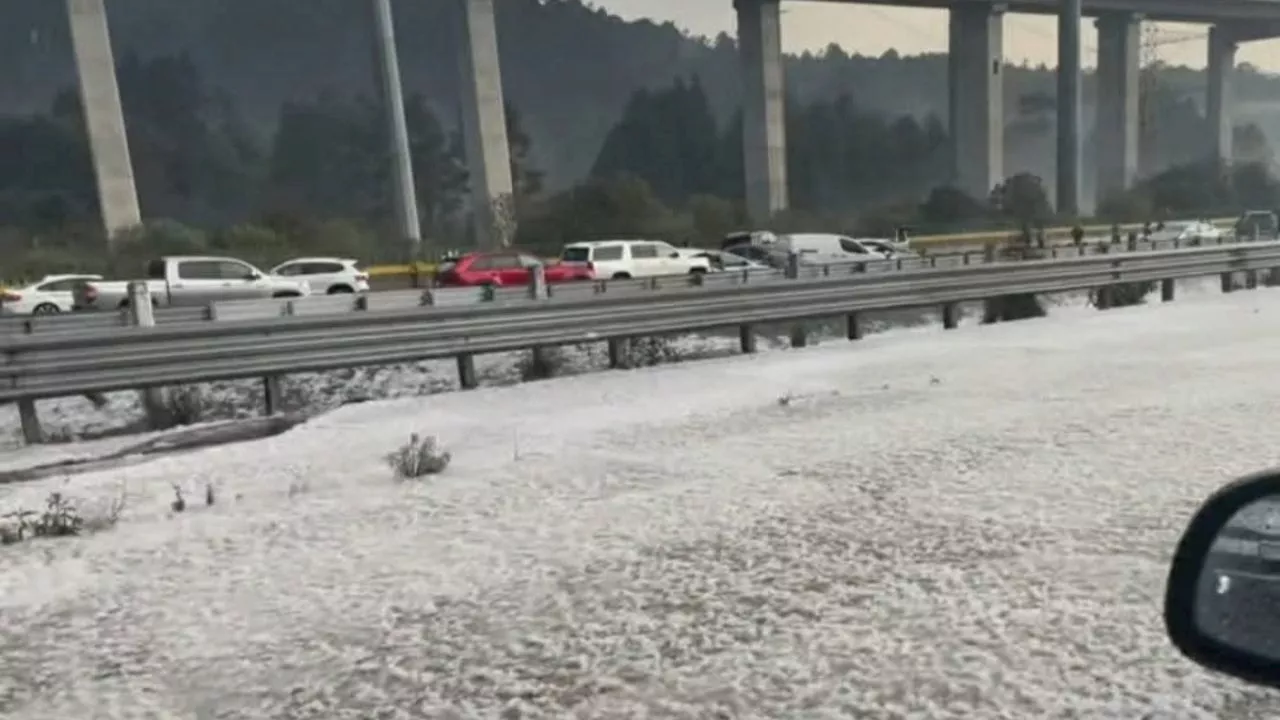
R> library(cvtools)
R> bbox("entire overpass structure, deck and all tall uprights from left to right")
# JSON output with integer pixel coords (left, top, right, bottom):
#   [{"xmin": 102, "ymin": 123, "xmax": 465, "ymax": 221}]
[{"xmin": 65, "ymin": 0, "xmax": 1280, "ymax": 246}]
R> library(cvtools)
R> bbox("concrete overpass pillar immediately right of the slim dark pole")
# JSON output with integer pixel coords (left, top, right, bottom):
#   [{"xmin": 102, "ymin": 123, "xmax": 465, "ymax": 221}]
[{"xmin": 1094, "ymin": 13, "xmax": 1142, "ymax": 202}]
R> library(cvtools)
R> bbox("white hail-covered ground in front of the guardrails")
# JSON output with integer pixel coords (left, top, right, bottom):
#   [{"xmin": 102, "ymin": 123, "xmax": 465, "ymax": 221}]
[{"xmin": 0, "ymin": 290, "xmax": 1280, "ymax": 720}]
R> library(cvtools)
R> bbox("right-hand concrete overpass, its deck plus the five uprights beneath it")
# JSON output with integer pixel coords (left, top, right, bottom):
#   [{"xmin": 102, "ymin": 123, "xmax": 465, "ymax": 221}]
[{"xmin": 735, "ymin": 0, "xmax": 1280, "ymax": 218}]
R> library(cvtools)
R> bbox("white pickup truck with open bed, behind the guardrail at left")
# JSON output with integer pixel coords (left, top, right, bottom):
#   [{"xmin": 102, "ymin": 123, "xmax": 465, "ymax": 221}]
[{"xmin": 74, "ymin": 255, "xmax": 311, "ymax": 310}]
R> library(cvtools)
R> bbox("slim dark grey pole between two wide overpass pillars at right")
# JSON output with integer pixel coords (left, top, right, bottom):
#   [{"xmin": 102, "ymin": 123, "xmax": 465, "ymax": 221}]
[{"xmin": 1057, "ymin": 0, "xmax": 1080, "ymax": 215}]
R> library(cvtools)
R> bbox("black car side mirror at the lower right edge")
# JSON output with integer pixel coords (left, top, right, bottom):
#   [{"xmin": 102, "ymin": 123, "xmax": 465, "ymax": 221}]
[{"xmin": 1165, "ymin": 469, "xmax": 1280, "ymax": 688}]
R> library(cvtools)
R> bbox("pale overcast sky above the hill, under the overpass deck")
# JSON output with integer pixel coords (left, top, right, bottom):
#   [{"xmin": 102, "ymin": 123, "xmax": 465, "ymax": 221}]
[{"xmin": 593, "ymin": 0, "xmax": 1280, "ymax": 72}]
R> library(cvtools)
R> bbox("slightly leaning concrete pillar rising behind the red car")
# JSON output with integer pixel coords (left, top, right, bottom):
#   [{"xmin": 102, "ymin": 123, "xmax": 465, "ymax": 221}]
[{"xmin": 460, "ymin": 0, "xmax": 516, "ymax": 249}]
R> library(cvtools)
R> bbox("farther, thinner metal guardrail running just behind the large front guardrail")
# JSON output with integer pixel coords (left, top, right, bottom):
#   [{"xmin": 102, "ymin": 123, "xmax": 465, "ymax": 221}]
[{"xmin": 0, "ymin": 240, "xmax": 1234, "ymax": 334}]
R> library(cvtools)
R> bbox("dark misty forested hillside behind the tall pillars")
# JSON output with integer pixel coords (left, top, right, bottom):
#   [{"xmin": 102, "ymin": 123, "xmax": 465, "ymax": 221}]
[{"xmin": 0, "ymin": 0, "xmax": 1280, "ymax": 274}]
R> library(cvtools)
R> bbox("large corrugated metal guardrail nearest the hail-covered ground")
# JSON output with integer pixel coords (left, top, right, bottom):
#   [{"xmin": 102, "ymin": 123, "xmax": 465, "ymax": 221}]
[{"xmin": 0, "ymin": 242, "xmax": 1280, "ymax": 418}]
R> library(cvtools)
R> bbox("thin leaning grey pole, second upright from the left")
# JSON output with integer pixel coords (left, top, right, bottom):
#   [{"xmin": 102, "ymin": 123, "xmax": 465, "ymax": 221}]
[{"xmin": 371, "ymin": 0, "xmax": 422, "ymax": 258}]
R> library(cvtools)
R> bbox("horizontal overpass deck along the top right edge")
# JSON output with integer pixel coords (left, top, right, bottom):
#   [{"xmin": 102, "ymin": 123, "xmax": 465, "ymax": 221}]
[{"xmin": 824, "ymin": 0, "xmax": 1280, "ymax": 25}]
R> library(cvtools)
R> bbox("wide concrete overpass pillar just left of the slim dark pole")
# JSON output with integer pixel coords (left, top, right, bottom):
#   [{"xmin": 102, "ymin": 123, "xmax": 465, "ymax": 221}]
[{"xmin": 947, "ymin": 3, "xmax": 1005, "ymax": 200}]
